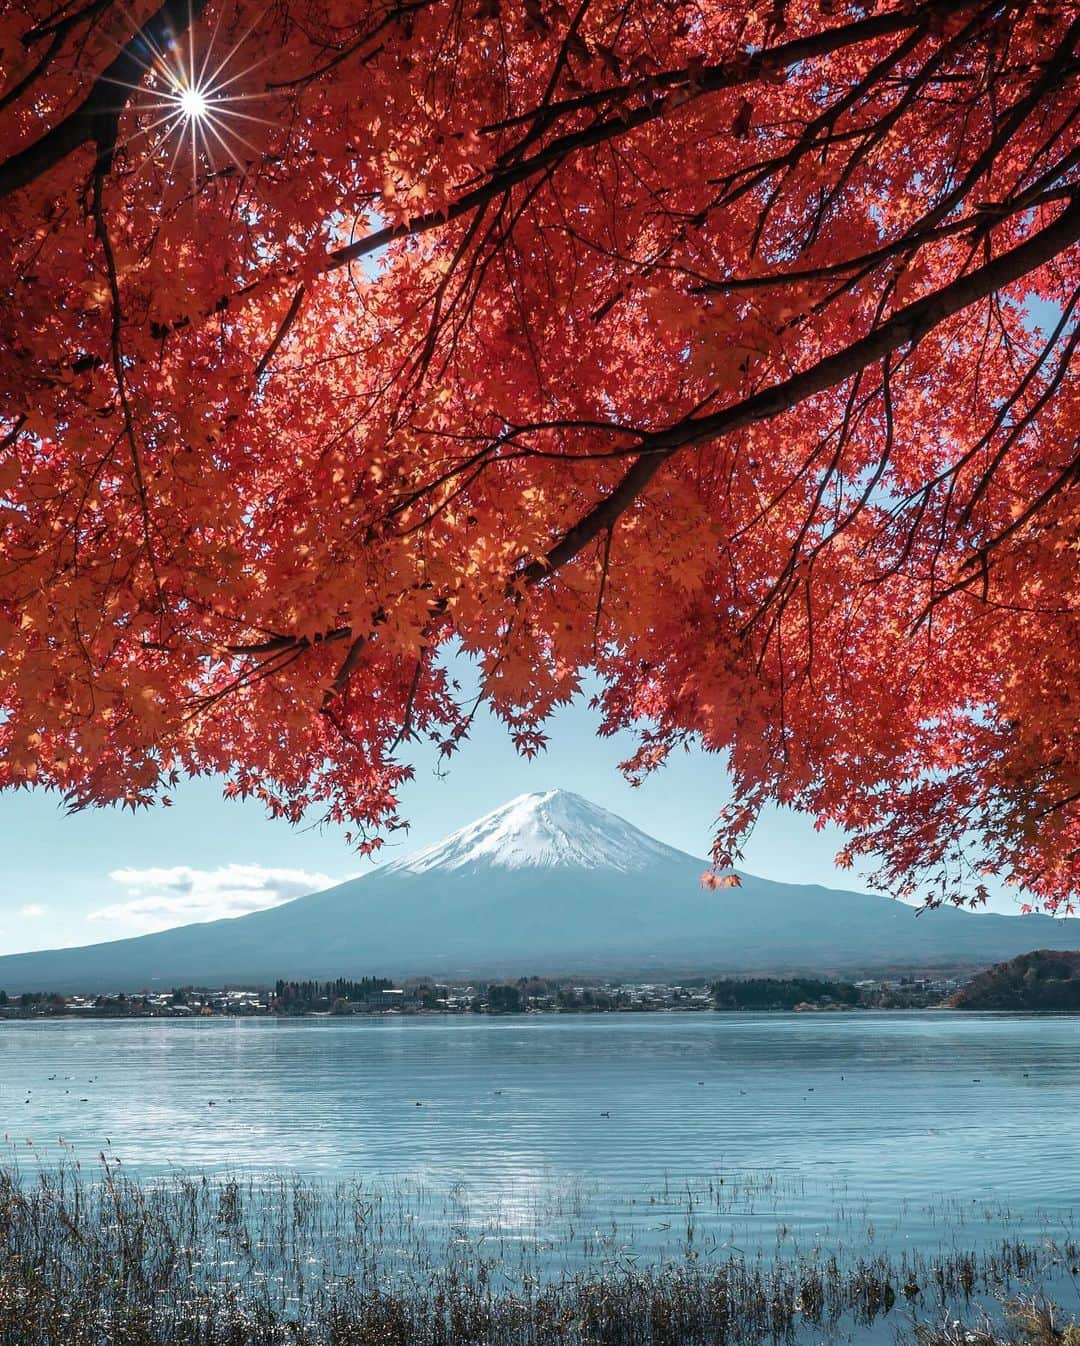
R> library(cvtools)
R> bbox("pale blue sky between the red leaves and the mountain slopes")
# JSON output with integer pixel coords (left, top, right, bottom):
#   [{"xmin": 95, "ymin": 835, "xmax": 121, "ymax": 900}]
[{"xmin": 0, "ymin": 673, "xmax": 1017, "ymax": 953}]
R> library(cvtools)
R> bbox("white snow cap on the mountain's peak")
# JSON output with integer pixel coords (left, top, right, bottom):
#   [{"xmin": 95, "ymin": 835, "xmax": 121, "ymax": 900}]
[{"xmin": 384, "ymin": 790, "xmax": 683, "ymax": 874}]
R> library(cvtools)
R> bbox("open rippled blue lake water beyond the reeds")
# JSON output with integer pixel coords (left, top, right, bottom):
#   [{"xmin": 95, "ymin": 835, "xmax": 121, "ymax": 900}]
[{"xmin": 0, "ymin": 1012, "xmax": 1080, "ymax": 1250}]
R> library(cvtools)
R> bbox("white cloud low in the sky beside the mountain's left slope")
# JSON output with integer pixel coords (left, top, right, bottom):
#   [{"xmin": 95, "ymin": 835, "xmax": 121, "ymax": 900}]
[{"xmin": 86, "ymin": 864, "xmax": 349, "ymax": 934}]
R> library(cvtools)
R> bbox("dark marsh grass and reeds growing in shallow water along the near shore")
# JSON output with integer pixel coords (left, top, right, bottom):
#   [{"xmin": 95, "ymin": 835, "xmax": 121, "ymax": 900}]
[{"xmin": 0, "ymin": 1163, "xmax": 1080, "ymax": 1346}]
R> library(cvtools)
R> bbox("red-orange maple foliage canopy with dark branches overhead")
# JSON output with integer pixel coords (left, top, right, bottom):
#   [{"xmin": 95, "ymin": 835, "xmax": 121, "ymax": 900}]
[{"xmin": 0, "ymin": 0, "xmax": 1080, "ymax": 907}]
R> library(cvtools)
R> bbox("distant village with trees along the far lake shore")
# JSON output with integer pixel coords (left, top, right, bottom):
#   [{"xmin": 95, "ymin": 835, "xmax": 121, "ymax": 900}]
[{"xmin": 0, "ymin": 976, "xmax": 968, "ymax": 1019}]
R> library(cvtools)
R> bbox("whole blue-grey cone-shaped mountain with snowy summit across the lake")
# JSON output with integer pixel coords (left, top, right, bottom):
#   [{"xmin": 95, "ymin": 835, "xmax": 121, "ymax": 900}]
[{"xmin": 0, "ymin": 790, "xmax": 1080, "ymax": 992}]
